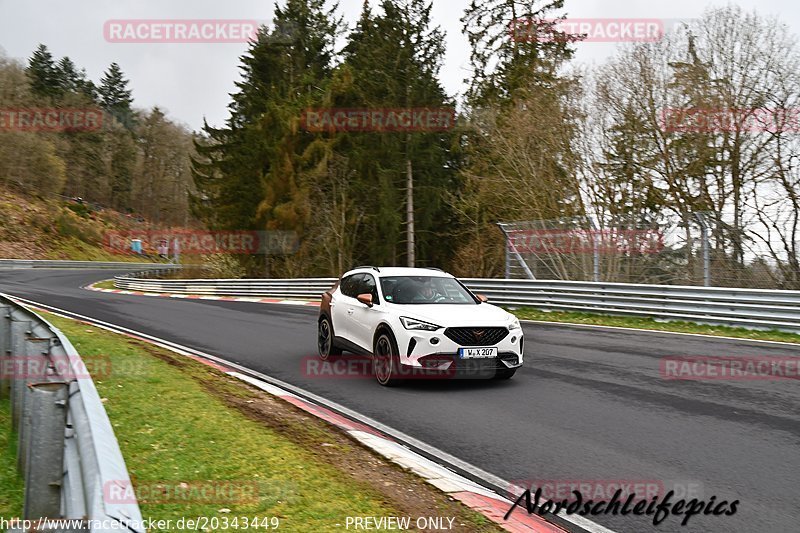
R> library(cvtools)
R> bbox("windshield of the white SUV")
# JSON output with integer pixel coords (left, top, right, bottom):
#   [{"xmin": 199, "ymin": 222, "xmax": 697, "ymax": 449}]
[{"xmin": 381, "ymin": 276, "xmax": 478, "ymax": 305}]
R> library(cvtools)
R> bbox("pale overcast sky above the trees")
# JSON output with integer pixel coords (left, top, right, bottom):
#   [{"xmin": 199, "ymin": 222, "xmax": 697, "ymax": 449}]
[{"xmin": 0, "ymin": 0, "xmax": 800, "ymax": 128}]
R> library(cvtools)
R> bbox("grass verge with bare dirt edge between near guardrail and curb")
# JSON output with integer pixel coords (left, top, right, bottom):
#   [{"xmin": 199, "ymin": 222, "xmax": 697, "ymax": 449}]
[{"xmin": 36, "ymin": 315, "xmax": 500, "ymax": 531}]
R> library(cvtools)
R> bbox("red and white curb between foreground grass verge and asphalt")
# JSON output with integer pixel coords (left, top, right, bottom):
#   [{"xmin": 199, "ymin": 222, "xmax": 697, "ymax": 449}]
[{"xmin": 12, "ymin": 297, "xmax": 600, "ymax": 533}]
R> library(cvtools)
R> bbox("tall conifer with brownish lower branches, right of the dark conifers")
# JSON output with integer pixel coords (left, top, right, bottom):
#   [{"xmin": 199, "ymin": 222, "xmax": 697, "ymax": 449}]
[{"xmin": 457, "ymin": 0, "xmax": 583, "ymax": 276}]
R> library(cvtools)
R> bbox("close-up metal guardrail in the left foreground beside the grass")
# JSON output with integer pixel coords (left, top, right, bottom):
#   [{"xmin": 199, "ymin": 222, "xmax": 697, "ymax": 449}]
[{"xmin": 0, "ymin": 294, "xmax": 145, "ymax": 532}]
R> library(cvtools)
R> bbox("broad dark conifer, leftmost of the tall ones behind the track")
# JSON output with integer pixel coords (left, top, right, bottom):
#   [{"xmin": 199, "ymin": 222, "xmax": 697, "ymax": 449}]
[{"xmin": 193, "ymin": 0, "xmax": 341, "ymax": 241}]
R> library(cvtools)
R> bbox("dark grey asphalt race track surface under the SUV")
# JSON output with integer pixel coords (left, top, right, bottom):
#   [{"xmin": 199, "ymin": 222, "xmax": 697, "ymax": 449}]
[{"xmin": 0, "ymin": 269, "xmax": 800, "ymax": 533}]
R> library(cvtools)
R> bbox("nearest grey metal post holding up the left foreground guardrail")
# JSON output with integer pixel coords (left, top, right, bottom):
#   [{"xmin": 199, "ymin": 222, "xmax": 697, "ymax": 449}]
[{"xmin": 23, "ymin": 381, "xmax": 69, "ymax": 520}]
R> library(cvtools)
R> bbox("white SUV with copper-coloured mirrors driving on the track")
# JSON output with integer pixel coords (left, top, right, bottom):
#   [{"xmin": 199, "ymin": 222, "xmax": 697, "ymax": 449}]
[{"xmin": 318, "ymin": 267, "xmax": 523, "ymax": 385}]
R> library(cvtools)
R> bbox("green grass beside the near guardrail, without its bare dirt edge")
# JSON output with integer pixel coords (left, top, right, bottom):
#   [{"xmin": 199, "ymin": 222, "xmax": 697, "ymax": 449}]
[{"xmin": 43, "ymin": 316, "xmax": 406, "ymax": 531}]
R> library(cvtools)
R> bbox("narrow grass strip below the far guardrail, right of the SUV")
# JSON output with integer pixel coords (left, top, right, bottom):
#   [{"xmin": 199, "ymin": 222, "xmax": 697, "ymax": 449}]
[{"xmin": 509, "ymin": 308, "xmax": 800, "ymax": 344}]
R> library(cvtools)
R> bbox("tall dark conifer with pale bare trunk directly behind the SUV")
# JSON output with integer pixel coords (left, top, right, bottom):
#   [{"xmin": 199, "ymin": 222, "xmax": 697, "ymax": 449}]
[{"xmin": 337, "ymin": 0, "xmax": 457, "ymax": 265}]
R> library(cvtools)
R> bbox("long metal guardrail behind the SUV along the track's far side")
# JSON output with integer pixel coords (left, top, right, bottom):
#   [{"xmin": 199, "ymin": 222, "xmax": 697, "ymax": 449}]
[{"xmin": 114, "ymin": 276, "xmax": 800, "ymax": 333}]
